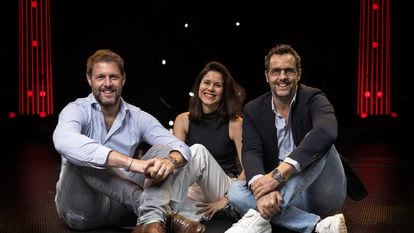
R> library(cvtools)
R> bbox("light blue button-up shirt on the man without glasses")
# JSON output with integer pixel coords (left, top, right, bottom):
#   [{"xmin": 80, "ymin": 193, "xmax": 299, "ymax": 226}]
[{"xmin": 53, "ymin": 94, "xmax": 191, "ymax": 170}]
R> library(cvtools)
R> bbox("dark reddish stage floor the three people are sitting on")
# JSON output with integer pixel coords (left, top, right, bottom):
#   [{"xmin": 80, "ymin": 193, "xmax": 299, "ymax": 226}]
[{"xmin": 0, "ymin": 117, "xmax": 414, "ymax": 233}]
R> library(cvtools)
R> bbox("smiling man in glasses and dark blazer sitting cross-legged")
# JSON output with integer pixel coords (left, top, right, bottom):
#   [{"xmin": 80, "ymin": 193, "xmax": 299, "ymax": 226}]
[{"xmin": 226, "ymin": 44, "xmax": 366, "ymax": 233}]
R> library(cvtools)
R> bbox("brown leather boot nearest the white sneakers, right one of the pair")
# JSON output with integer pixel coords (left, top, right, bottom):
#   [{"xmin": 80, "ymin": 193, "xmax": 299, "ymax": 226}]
[{"xmin": 169, "ymin": 214, "xmax": 206, "ymax": 233}]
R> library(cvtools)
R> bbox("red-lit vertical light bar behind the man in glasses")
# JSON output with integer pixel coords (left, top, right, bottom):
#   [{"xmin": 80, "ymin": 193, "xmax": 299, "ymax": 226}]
[{"xmin": 357, "ymin": 0, "xmax": 391, "ymax": 118}]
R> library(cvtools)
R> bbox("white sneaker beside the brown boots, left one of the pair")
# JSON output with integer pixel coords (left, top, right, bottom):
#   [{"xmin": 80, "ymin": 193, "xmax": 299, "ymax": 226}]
[{"xmin": 225, "ymin": 209, "xmax": 272, "ymax": 233}]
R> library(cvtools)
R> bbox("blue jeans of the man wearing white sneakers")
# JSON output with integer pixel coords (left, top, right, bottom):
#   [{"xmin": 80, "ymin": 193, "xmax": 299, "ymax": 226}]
[{"xmin": 228, "ymin": 146, "xmax": 347, "ymax": 233}]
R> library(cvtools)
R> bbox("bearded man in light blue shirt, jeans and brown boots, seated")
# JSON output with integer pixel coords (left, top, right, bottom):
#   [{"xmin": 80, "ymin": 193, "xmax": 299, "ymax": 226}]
[{"xmin": 53, "ymin": 49, "xmax": 204, "ymax": 233}]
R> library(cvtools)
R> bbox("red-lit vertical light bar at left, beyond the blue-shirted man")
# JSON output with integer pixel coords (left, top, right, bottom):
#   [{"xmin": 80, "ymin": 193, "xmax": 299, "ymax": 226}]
[{"xmin": 18, "ymin": 0, "xmax": 54, "ymax": 117}]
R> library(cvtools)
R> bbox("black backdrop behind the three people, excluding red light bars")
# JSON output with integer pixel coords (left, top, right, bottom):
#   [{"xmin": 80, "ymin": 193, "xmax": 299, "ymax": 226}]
[{"xmin": 0, "ymin": 0, "xmax": 414, "ymax": 137}]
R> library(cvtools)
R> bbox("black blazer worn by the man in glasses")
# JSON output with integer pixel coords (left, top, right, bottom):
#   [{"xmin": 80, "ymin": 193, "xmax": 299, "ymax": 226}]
[{"xmin": 242, "ymin": 84, "xmax": 367, "ymax": 200}]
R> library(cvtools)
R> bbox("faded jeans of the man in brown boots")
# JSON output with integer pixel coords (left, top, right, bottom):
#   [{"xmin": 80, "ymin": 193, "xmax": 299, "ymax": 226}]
[{"xmin": 55, "ymin": 145, "xmax": 188, "ymax": 230}]
